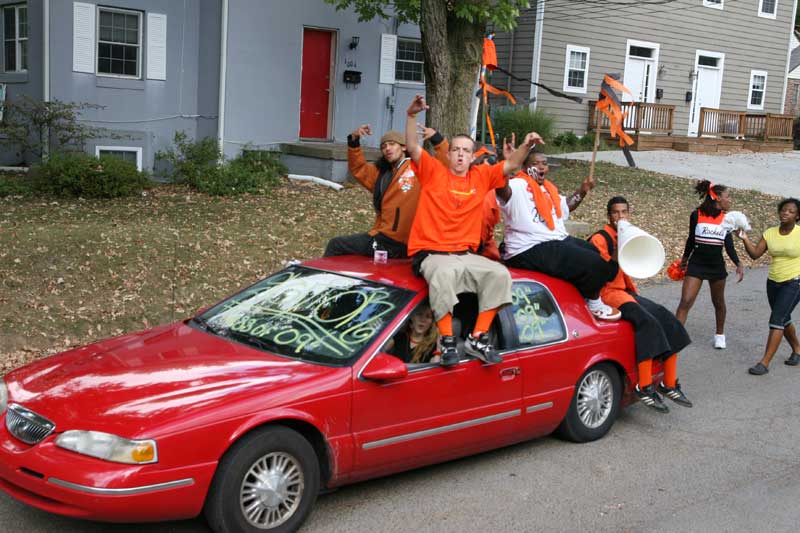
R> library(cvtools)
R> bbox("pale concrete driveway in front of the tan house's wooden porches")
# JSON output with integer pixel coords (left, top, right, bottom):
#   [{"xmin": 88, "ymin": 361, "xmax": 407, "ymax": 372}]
[{"xmin": 550, "ymin": 150, "xmax": 800, "ymax": 198}]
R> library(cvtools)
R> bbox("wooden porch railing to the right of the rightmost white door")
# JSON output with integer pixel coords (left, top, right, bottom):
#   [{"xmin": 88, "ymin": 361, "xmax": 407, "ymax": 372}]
[{"xmin": 697, "ymin": 107, "xmax": 794, "ymax": 141}]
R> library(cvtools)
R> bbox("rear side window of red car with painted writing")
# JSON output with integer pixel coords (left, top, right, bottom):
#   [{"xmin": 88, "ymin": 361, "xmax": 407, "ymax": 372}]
[{"xmin": 511, "ymin": 281, "xmax": 567, "ymax": 346}]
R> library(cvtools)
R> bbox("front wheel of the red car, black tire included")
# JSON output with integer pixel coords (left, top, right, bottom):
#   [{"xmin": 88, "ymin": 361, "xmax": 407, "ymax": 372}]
[{"xmin": 204, "ymin": 426, "xmax": 320, "ymax": 533}]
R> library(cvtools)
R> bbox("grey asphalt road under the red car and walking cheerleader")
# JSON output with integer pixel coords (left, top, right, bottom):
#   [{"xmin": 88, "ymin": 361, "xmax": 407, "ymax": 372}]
[{"xmin": 0, "ymin": 269, "xmax": 800, "ymax": 533}]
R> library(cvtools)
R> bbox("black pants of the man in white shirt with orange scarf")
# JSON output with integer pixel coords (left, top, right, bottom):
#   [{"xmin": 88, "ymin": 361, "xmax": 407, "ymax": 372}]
[{"xmin": 506, "ymin": 237, "xmax": 619, "ymax": 298}]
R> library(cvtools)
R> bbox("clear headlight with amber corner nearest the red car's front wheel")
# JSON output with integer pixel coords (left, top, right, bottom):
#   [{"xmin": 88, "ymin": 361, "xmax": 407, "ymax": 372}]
[{"xmin": 56, "ymin": 430, "xmax": 158, "ymax": 465}]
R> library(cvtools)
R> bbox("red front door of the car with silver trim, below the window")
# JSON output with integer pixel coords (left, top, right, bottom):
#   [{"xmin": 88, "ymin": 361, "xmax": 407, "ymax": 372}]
[{"xmin": 352, "ymin": 336, "xmax": 522, "ymax": 478}]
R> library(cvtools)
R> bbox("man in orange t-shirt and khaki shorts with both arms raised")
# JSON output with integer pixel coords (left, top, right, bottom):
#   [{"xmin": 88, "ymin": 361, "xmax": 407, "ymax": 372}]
[{"xmin": 406, "ymin": 95, "xmax": 542, "ymax": 366}]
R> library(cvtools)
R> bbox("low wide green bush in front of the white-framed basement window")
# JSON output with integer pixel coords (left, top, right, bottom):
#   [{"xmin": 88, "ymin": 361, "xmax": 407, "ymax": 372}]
[{"xmin": 30, "ymin": 152, "xmax": 152, "ymax": 198}]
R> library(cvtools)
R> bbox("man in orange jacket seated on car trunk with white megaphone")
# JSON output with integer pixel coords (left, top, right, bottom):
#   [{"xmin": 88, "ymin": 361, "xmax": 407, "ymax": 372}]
[{"xmin": 589, "ymin": 196, "xmax": 692, "ymax": 413}]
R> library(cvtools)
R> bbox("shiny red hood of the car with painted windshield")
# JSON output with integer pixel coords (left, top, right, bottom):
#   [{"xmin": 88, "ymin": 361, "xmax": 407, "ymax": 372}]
[{"xmin": 6, "ymin": 323, "xmax": 350, "ymax": 436}]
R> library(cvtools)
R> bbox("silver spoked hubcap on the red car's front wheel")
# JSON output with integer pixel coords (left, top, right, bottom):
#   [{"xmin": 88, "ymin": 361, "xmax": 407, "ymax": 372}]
[{"xmin": 239, "ymin": 452, "xmax": 305, "ymax": 529}]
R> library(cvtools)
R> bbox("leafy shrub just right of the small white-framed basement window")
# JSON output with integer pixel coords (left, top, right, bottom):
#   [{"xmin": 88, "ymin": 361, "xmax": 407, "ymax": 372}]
[{"xmin": 156, "ymin": 131, "xmax": 222, "ymax": 188}]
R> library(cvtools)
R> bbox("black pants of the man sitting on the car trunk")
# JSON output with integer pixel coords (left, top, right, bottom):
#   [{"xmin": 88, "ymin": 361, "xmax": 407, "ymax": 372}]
[{"xmin": 619, "ymin": 294, "xmax": 692, "ymax": 363}]
